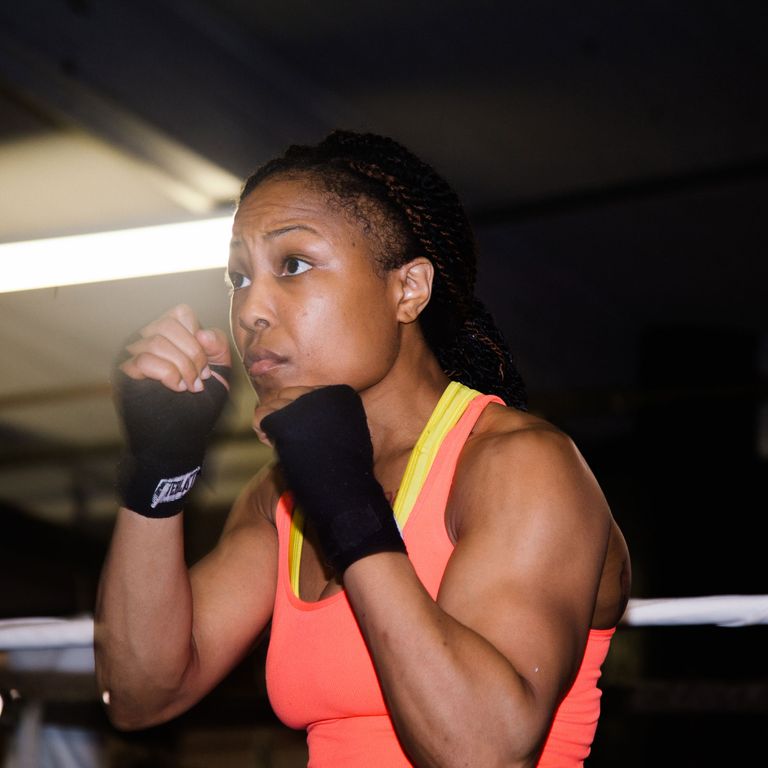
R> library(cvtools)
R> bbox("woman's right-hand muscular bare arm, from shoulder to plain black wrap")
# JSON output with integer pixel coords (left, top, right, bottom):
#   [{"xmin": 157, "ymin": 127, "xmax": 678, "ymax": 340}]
[{"xmin": 344, "ymin": 430, "xmax": 610, "ymax": 768}]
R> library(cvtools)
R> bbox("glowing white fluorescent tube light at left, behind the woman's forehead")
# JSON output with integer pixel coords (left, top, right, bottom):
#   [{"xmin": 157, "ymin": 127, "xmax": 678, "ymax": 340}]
[{"xmin": 0, "ymin": 216, "xmax": 232, "ymax": 293}]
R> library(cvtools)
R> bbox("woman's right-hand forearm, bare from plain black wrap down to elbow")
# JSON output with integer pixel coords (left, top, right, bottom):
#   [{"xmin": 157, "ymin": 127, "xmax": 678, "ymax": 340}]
[{"xmin": 344, "ymin": 554, "xmax": 542, "ymax": 768}]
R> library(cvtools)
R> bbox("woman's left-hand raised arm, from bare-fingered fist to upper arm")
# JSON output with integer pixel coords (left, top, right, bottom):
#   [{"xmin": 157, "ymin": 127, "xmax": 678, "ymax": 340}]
[{"xmin": 95, "ymin": 305, "xmax": 277, "ymax": 728}]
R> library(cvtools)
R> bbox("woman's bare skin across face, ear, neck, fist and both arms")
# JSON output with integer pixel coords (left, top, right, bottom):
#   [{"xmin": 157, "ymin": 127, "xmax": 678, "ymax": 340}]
[{"xmin": 97, "ymin": 179, "xmax": 629, "ymax": 768}]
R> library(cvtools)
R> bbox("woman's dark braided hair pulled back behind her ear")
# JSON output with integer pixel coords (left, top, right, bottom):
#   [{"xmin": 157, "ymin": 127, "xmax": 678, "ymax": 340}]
[{"xmin": 239, "ymin": 131, "xmax": 527, "ymax": 410}]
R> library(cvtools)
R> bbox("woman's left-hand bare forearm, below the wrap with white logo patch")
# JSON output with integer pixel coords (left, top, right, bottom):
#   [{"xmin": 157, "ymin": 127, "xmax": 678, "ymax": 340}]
[{"xmin": 95, "ymin": 509, "xmax": 195, "ymax": 728}]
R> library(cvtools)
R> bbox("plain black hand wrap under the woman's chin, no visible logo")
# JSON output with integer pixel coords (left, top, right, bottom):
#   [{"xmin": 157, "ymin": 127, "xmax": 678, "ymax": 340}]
[{"xmin": 261, "ymin": 385, "xmax": 405, "ymax": 573}]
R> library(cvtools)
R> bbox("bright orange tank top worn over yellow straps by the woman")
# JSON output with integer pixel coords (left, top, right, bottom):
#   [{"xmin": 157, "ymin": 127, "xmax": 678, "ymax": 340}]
[{"xmin": 267, "ymin": 388, "xmax": 614, "ymax": 768}]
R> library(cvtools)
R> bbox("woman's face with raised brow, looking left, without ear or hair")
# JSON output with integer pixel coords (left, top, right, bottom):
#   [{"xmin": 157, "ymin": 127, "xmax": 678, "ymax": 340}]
[{"xmin": 228, "ymin": 179, "xmax": 399, "ymax": 402}]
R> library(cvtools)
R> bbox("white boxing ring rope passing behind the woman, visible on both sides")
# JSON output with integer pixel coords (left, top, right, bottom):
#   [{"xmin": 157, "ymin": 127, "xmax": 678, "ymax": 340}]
[{"xmin": 0, "ymin": 595, "xmax": 768, "ymax": 651}]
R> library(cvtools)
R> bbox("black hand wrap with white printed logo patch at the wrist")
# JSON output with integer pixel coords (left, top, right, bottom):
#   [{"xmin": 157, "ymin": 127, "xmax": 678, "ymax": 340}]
[{"xmin": 112, "ymin": 365, "xmax": 231, "ymax": 517}]
